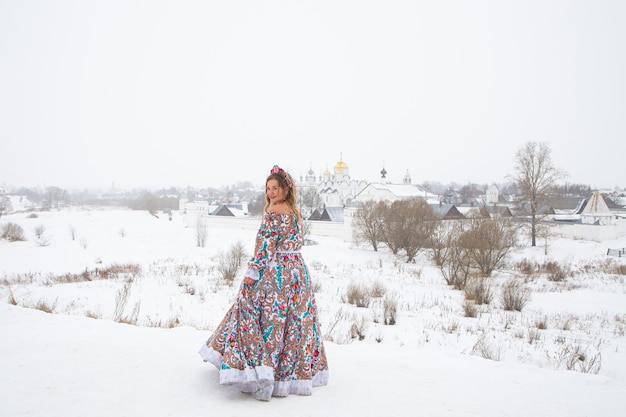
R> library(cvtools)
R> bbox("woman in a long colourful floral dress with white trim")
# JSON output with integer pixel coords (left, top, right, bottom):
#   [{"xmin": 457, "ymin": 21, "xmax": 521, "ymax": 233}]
[{"xmin": 200, "ymin": 165, "xmax": 328, "ymax": 401}]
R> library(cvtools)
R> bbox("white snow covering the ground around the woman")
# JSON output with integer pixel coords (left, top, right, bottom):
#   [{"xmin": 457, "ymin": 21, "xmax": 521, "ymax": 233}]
[{"xmin": 0, "ymin": 209, "xmax": 626, "ymax": 417}]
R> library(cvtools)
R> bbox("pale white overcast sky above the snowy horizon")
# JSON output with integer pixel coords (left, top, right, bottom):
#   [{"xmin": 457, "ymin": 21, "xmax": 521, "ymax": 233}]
[{"xmin": 0, "ymin": 0, "xmax": 626, "ymax": 188}]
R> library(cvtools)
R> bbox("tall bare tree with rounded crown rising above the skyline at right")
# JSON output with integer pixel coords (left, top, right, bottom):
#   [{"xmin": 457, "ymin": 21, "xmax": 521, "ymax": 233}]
[{"xmin": 514, "ymin": 142, "xmax": 566, "ymax": 246}]
